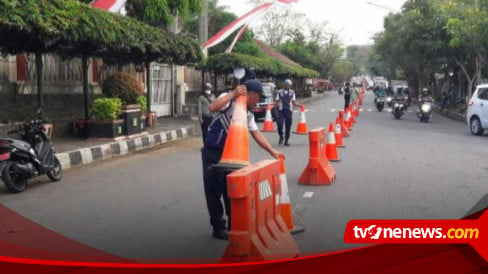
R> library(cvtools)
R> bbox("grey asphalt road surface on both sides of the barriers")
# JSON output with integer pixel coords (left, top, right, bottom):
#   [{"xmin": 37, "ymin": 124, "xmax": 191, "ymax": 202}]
[{"xmin": 0, "ymin": 92, "xmax": 488, "ymax": 259}]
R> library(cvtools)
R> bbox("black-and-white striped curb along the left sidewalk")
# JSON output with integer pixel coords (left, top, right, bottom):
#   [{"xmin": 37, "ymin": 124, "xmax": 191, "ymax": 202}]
[{"xmin": 56, "ymin": 126, "xmax": 194, "ymax": 169}]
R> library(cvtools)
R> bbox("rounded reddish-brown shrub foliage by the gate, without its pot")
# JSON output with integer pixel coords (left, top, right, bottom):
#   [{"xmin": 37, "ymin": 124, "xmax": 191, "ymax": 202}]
[{"xmin": 102, "ymin": 72, "xmax": 144, "ymax": 104}]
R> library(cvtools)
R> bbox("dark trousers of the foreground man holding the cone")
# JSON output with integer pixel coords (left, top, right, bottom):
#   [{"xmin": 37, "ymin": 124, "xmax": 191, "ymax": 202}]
[{"xmin": 202, "ymin": 146, "xmax": 231, "ymax": 231}]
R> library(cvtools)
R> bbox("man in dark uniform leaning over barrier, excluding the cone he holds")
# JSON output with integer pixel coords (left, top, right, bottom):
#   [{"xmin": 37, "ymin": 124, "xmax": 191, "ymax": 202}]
[{"xmin": 202, "ymin": 79, "xmax": 284, "ymax": 240}]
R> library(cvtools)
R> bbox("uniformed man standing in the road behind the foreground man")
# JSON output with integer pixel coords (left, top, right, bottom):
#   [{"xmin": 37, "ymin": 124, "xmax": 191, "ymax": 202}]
[{"xmin": 275, "ymin": 79, "xmax": 303, "ymax": 146}]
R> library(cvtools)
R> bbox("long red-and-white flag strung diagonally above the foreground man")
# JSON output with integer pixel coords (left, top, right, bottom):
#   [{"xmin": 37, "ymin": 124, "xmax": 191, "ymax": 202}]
[{"xmin": 202, "ymin": 0, "xmax": 297, "ymax": 52}]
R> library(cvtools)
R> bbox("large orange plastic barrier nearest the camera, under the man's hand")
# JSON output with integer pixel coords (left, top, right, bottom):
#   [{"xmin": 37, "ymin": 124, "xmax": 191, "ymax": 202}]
[{"xmin": 221, "ymin": 160, "xmax": 300, "ymax": 263}]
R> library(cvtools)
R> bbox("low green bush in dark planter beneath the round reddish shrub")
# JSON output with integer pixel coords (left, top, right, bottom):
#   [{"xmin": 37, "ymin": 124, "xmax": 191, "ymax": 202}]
[{"xmin": 86, "ymin": 98, "xmax": 124, "ymax": 138}]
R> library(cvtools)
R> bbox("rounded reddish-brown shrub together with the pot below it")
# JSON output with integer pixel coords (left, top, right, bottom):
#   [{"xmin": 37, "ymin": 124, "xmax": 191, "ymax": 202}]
[{"xmin": 102, "ymin": 72, "xmax": 144, "ymax": 135}]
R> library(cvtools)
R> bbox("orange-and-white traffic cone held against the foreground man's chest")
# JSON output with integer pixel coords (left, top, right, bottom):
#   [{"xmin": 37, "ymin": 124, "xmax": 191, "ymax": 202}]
[{"xmin": 213, "ymin": 95, "xmax": 249, "ymax": 171}]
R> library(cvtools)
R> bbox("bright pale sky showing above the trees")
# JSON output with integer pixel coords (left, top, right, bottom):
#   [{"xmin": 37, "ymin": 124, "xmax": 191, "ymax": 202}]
[{"xmin": 218, "ymin": 0, "xmax": 406, "ymax": 45}]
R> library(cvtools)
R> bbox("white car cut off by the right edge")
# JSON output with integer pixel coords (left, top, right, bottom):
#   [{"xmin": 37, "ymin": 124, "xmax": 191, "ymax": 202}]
[{"xmin": 466, "ymin": 84, "xmax": 488, "ymax": 135}]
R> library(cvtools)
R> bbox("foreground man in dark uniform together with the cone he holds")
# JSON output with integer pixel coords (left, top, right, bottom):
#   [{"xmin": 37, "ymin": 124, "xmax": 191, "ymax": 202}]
[{"xmin": 202, "ymin": 80, "xmax": 283, "ymax": 240}]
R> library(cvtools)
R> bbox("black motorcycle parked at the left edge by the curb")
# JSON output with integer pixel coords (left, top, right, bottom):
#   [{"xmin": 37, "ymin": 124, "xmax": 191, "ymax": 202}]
[{"xmin": 0, "ymin": 111, "xmax": 63, "ymax": 193}]
